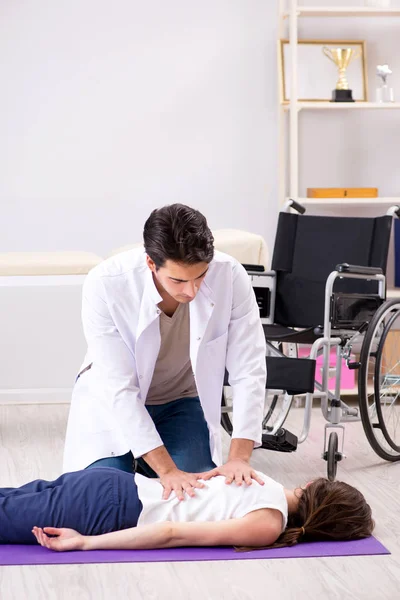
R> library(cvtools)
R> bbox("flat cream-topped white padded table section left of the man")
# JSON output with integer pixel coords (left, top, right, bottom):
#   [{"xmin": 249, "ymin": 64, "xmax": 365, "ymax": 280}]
[{"xmin": 0, "ymin": 251, "xmax": 103, "ymax": 404}]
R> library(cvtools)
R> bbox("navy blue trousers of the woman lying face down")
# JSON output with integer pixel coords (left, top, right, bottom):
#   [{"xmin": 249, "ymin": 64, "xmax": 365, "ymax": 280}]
[{"xmin": 0, "ymin": 469, "xmax": 142, "ymax": 544}]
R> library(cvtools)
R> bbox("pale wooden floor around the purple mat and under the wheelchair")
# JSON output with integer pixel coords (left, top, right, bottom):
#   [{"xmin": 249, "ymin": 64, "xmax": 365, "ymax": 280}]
[{"xmin": 0, "ymin": 405, "xmax": 400, "ymax": 600}]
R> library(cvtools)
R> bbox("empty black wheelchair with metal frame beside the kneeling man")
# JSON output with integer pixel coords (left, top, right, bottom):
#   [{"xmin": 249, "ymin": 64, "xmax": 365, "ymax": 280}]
[{"xmin": 221, "ymin": 200, "xmax": 400, "ymax": 480}]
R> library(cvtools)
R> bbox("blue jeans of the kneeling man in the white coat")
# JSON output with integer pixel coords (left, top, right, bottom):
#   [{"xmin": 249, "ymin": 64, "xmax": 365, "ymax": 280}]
[{"xmin": 87, "ymin": 397, "xmax": 216, "ymax": 477}]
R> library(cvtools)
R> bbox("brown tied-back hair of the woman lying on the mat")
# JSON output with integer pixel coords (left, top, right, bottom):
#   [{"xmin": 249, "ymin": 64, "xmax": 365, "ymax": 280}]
[{"xmin": 236, "ymin": 478, "xmax": 375, "ymax": 552}]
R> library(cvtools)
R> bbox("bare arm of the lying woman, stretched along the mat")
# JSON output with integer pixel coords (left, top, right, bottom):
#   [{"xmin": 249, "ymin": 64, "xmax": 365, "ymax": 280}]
[{"xmin": 36, "ymin": 509, "xmax": 282, "ymax": 550}]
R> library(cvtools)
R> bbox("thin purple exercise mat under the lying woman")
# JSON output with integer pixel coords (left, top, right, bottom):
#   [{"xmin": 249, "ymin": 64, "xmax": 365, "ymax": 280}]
[{"xmin": 0, "ymin": 537, "xmax": 390, "ymax": 566}]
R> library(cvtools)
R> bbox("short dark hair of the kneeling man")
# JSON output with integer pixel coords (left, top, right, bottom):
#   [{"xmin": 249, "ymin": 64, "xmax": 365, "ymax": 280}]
[{"xmin": 143, "ymin": 204, "xmax": 214, "ymax": 269}]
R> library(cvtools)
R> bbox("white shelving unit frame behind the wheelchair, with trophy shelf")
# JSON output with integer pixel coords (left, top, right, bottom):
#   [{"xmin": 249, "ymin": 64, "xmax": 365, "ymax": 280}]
[{"xmin": 278, "ymin": 0, "xmax": 400, "ymax": 206}]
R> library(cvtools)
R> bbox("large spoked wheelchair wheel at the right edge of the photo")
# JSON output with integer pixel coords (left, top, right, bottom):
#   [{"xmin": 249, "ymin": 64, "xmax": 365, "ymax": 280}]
[{"xmin": 358, "ymin": 299, "xmax": 400, "ymax": 462}]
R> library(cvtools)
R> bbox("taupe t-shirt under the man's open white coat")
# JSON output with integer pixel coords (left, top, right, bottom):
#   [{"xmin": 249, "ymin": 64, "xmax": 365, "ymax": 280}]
[{"xmin": 146, "ymin": 304, "xmax": 198, "ymax": 404}]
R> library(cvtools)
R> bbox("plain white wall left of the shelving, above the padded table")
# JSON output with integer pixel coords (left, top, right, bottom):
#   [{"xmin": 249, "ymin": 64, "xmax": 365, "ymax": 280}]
[{"xmin": 0, "ymin": 0, "xmax": 277, "ymax": 255}]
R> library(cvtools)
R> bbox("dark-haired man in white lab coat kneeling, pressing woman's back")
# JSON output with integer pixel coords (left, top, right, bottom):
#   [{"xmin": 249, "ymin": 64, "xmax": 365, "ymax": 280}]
[{"xmin": 64, "ymin": 204, "xmax": 266, "ymax": 499}]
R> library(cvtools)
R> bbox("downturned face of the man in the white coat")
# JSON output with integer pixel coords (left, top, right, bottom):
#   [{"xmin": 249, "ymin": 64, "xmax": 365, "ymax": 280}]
[{"xmin": 147, "ymin": 257, "xmax": 209, "ymax": 304}]
